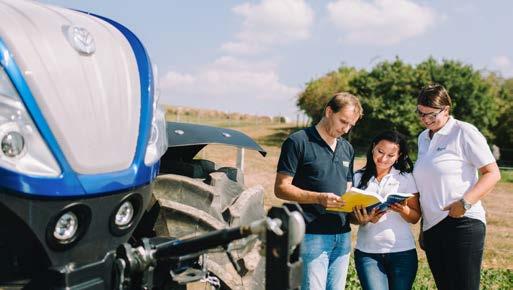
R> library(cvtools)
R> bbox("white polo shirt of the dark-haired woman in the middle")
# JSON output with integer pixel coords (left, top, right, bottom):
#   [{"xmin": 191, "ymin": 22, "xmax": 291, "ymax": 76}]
[{"xmin": 354, "ymin": 168, "xmax": 417, "ymax": 254}]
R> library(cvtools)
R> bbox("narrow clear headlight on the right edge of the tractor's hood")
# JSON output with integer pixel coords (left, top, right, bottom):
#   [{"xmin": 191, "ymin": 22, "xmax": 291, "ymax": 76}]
[{"xmin": 144, "ymin": 65, "xmax": 167, "ymax": 165}]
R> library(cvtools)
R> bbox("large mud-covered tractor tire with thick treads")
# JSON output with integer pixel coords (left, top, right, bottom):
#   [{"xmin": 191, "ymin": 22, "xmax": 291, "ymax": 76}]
[{"xmin": 154, "ymin": 160, "xmax": 265, "ymax": 289}]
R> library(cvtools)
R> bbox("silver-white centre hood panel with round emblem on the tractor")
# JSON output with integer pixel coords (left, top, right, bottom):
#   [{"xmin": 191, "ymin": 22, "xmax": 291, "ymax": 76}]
[{"xmin": 0, "ymin": 0, "xmax": 140, "ymax": 174}]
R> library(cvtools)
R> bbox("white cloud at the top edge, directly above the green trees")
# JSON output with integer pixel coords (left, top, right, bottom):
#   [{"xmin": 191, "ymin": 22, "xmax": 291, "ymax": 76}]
[{"xmin": 327, "ymin": 0, "xmax": 437, "ymax": 45}]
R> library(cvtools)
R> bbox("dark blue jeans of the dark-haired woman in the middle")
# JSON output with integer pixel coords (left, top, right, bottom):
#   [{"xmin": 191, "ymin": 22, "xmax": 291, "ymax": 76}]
[{"xmin": 354, "ymin": 249, "xmax": 418, "ymax": 290}]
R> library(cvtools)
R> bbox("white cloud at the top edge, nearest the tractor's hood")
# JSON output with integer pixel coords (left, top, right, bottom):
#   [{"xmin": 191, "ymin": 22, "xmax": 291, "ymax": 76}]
[{"xmin": 221, "ymin": 0, "xmax": 314, "ymax": 54}]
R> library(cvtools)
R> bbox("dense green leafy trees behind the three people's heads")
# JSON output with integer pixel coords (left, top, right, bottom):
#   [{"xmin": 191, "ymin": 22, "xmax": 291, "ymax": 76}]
[{"xmin": 297, "ymin": 58, "xmax": 513, "ymax": 160}]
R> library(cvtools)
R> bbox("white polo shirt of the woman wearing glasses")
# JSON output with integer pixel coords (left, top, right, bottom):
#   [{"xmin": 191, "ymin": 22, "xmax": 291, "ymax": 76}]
[{"xmin": 413, "ymin": 116, "xmax": 495, "ymax": 231}]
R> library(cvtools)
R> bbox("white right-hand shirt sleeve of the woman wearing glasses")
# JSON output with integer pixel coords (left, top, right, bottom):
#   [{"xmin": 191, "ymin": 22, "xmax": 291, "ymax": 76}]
[{"xmin": 462, "ymin": 125, "xmax": 495, "ymax": 169}]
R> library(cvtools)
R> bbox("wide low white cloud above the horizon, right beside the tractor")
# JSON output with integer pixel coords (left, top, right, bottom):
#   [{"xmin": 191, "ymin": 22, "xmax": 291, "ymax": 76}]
[{"xmin": 160, "ymin": 57, "xmax": 300, "ymax": 115}]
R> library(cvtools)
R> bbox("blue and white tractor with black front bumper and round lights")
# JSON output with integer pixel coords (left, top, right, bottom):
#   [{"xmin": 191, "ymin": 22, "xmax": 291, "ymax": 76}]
[{"xmin": 0, "ymin": 0, "xmax": 304, "ymax": 289}]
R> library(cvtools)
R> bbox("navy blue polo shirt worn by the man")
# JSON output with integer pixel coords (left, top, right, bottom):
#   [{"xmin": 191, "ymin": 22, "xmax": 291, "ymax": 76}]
[{"xmin": 277, "ymin": 126, "xmax": 354, "ymax": 234}]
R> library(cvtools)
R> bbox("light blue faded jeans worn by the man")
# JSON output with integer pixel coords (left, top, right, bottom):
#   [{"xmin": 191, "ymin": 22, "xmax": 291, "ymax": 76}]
[{"xmin": 301, "ymin": 232, "xmax": 351, "ymax": 290}]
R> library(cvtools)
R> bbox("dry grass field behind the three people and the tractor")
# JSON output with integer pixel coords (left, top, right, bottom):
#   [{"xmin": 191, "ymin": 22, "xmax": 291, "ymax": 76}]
[{"xmin": 173, "ymin": 118, "xmax": 513, "ymax": 289}]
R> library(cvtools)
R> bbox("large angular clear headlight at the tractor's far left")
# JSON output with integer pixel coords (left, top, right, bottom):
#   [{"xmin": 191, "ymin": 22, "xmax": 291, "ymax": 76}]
[{"xmin": 0, "ymin": 66, "xmax": 61, "ymax": 177}]
